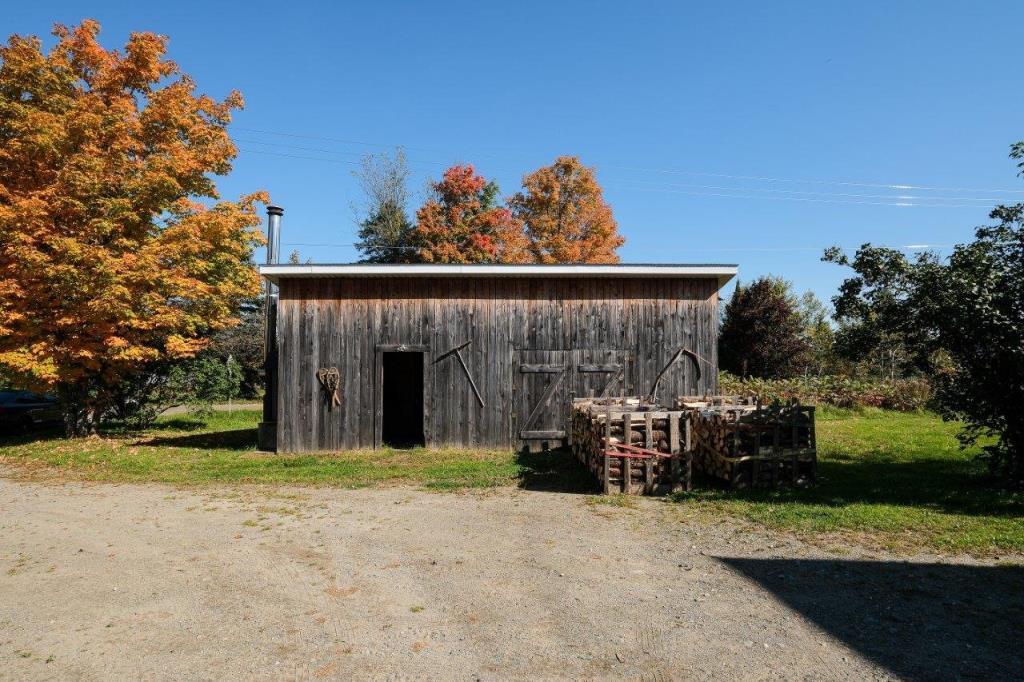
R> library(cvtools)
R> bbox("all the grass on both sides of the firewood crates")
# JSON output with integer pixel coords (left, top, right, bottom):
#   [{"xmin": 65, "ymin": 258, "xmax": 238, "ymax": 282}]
[{"xmin": 0, "ymin": 403, "xmax": 1024, "ymax": 555}]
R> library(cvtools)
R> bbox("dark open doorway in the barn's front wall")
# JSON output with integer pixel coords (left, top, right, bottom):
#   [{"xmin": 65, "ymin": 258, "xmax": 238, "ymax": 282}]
[{"xmin": 381, "ymin": 352, "xmax": 425, "ymax": 447}]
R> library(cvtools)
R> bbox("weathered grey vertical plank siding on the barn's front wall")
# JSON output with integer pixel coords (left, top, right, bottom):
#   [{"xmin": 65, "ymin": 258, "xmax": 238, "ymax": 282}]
[{"xmin": 278, "ymin": 278, "xmax": 718, "ymax": 452}]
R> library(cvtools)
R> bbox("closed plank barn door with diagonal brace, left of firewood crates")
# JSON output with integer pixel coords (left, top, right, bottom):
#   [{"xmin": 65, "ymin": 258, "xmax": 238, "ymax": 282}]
[{"xmin": 513, "ymin": 350, "xmax": 571, "ymax": 451}]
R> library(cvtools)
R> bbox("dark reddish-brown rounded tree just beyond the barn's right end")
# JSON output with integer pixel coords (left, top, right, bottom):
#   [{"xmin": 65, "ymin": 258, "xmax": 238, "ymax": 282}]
[{"xmin": 719, "ymin": 278, "xmax": 810, "ymax": 379}]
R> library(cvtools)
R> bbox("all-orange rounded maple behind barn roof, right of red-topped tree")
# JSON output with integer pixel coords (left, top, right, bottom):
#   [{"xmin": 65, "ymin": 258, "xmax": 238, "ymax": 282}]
[{"xmin": 509, "ymin": 157, "xmax": 626, "ymax": 263}]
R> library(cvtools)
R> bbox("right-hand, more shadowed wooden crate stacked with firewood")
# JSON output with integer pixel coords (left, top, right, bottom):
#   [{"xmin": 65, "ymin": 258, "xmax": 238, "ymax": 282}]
[{"xmin": 676, "ymin": 396, "xmax": 817, "ymax": 487}]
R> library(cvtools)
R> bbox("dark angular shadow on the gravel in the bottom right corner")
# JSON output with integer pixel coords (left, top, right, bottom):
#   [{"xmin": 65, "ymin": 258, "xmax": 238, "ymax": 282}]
[{"xmin": 718, "ymin": 557, "xmax": 1024, "ymax": 680}]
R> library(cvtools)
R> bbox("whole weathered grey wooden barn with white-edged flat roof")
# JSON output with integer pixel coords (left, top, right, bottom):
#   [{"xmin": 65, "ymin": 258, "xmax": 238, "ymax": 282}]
[{"xmin": 261, "ymin": 264, "xmax": 736, "ymax": 453}]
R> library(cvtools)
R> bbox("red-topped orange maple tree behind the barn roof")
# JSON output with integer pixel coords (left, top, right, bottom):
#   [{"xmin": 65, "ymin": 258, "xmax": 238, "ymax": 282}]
[{"xmin": 410, "ymin": 165, "xmax": 529, "ymax": 263}]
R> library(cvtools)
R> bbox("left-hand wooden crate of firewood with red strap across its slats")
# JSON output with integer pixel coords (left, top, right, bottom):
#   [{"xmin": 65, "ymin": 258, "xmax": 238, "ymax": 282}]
[{"xmin": 570, "ymin": 397, "xmax": 692, "ymax": 495}]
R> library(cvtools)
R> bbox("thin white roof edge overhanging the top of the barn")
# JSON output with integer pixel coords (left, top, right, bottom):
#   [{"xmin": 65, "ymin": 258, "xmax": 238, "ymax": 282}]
[{"xmin": 259, "ymin": 263, "xmax": 736, "ymax": 288}]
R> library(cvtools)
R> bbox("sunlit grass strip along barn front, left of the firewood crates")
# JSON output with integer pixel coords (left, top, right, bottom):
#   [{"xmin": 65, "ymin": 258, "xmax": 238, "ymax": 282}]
[{"xmin": 0, "ymin": 411, "xmax": 519, "ymax": 487}]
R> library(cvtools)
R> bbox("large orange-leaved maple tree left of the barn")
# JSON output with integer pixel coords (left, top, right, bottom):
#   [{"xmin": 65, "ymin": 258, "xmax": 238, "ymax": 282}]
[{"xmin": 0, "ymin": 20, "xmax": 267, "ymax": 433}]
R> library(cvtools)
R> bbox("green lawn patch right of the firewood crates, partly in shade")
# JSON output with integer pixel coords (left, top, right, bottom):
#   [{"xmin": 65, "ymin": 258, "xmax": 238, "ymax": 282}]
[{"xmin": 677, "ymin": 409, "xmax": 1024, "ymax": 554}]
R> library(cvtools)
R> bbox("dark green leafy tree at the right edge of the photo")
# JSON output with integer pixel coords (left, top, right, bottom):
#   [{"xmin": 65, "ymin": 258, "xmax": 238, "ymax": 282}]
[{"xmin": 824, "ymin": 143, "xmax": 1024, "ymax": 487}]
